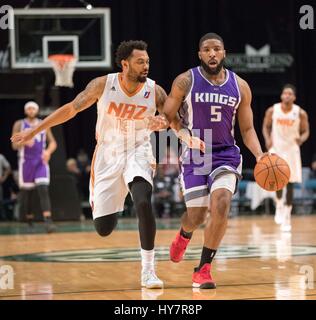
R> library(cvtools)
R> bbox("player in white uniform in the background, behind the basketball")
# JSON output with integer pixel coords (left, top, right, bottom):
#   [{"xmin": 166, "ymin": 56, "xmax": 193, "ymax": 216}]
[{"xmin": 262, "ymin": 84, "xmax": 309, "ymax": 232}]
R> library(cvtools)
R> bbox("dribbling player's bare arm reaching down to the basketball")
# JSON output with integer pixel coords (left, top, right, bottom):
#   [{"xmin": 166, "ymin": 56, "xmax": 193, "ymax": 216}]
[{"xmin": 238, "ymin": 77, "xmax": 263, "ymax": 161}]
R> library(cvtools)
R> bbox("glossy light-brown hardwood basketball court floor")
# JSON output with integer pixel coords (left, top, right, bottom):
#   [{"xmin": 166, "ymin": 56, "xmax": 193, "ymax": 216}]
[{"xmin": 0, "ymin": 215, "xmax": 316, "ymax": 300}]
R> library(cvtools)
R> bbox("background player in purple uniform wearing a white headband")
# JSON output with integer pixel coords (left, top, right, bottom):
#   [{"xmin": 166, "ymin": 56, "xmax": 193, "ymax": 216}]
[{"xmin": 12, "ymin": 101, "xmax": 57, "ymax": 233}]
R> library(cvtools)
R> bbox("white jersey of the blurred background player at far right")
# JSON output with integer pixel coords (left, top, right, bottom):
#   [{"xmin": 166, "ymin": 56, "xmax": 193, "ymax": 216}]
[{"xmin": 272, "ymin": 103, "xmax": 300, "ymax": 150}]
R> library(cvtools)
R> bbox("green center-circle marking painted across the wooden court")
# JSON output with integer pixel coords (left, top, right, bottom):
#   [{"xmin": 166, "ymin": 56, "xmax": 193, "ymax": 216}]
[{"xmin": 0, "ymin": 244, "xmax": 316, "ymax": 263}]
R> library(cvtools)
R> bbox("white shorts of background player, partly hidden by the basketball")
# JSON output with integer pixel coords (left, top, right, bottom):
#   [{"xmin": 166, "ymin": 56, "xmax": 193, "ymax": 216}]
[{"xmin": 269, "ymin": 146, "xmax": 302, "ymax": 183}]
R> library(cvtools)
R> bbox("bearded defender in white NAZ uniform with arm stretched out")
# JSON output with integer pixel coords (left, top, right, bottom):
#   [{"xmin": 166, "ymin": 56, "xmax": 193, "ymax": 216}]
[{"xmin": 11, "ymin": 41, "xmax": 166, "ymax": 288}]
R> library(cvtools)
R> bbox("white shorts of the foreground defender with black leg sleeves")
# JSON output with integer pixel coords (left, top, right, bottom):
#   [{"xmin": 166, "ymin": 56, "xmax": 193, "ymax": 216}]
[{"xmin": 90, "ymin": 143, "xmax": 156, "ymax": 219}]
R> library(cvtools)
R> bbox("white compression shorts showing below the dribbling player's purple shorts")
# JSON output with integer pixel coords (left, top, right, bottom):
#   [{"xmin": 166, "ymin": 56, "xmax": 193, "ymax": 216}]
[{"xmin": 185, "ymin": 172, "xmax": 237, "ymax": 208}]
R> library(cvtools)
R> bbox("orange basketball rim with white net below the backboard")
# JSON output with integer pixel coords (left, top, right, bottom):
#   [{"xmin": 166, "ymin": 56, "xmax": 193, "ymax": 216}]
[{"xmin": 48, "ymin": 54, "xmax": 77, "ymax": 88}]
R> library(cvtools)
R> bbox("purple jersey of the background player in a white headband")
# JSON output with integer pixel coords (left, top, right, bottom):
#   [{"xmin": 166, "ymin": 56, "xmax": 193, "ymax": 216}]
[{"xmin": 19, "ymin": 119, "xmax": 46, "ymax": 160}]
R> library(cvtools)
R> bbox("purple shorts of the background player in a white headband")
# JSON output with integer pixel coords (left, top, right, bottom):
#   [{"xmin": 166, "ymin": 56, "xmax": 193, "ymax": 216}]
[{"xmin": 19, "ymin": 159, "xmax": 50, "ymax": 188}]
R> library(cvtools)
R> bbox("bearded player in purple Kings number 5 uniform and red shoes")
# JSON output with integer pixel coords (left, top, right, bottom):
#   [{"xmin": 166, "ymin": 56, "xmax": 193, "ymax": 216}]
[{"xmin": 151, "ymin": 33, "xmax": 263, "ymax": 289}]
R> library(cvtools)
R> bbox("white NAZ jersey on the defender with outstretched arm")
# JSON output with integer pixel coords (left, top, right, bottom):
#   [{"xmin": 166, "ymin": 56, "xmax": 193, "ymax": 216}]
[{"xmin": 96, "ymin": 73, "xmax": 156, "ymax": 148}]
